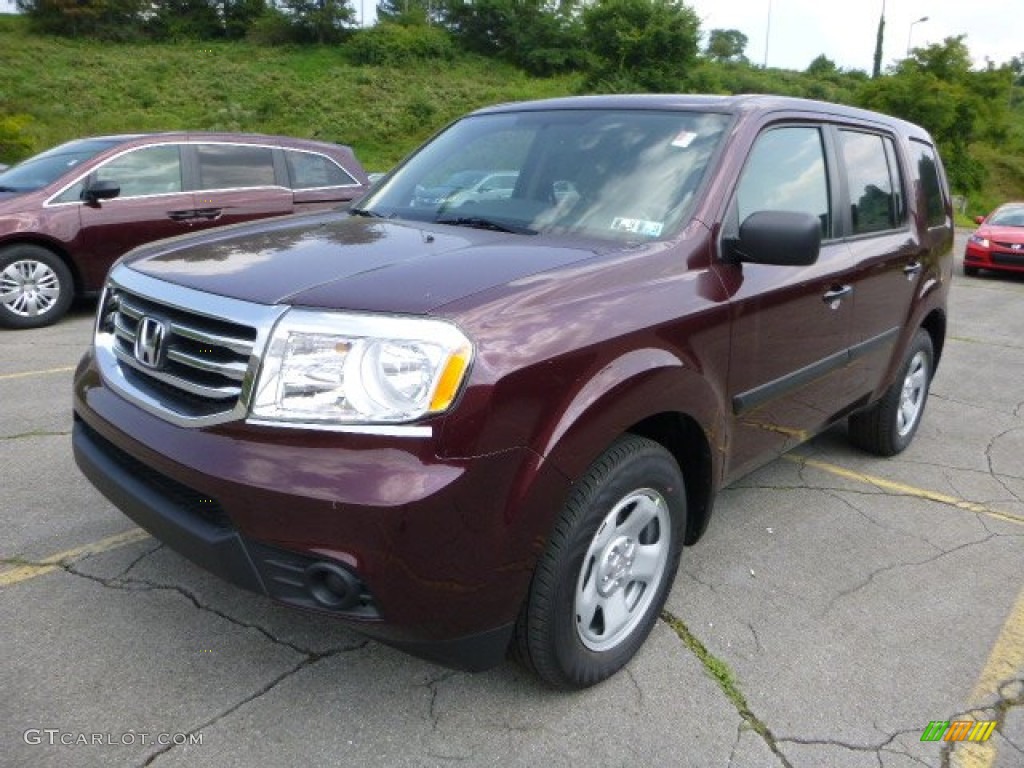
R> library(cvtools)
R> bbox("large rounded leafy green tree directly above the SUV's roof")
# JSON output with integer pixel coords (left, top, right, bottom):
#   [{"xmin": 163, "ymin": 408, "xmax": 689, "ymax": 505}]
[{"xmin": 583, "ymin": 0, "xmax": 700, "ymax": 91}]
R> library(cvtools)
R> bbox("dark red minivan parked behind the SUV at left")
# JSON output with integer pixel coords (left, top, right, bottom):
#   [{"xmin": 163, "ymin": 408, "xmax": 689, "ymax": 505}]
[{"xmin": 0, "ymin": 133, "xmax": 369, "ymax": 328}]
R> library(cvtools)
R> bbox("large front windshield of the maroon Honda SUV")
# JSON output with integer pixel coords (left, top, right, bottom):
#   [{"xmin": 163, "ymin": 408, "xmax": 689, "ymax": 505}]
[{"xmin": 353, "ymin": 110, "xmax": 729, "ymax": 241}]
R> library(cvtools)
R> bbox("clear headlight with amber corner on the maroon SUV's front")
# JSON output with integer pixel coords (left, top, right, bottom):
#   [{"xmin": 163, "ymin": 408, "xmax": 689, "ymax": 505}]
[{"xmin": 250, "ymin": 309, "xmax": 473, "ymax": 424}]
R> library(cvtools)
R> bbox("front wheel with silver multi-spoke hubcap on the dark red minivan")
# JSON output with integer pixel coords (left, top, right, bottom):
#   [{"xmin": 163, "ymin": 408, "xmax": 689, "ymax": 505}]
[{"xmin": 0, "ymin": 244, "xmax": 75, "ymax": 328}]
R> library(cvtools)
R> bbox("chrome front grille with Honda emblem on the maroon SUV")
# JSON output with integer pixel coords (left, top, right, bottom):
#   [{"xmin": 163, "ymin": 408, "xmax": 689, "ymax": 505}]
[{"xmin": 95, "ymin": 268, "xmax": 285, "ymax": 426}]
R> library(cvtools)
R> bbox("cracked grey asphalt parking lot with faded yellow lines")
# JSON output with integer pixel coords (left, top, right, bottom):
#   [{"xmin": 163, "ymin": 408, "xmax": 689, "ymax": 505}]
[{"xmin": 0, "ymin": 232, "xmax": 1024, "ymax": 768}]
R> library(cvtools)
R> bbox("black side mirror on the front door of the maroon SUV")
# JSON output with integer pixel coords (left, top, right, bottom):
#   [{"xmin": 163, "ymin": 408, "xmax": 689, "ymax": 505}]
[{"xmin": 729, "ymin": 211, "xmax": 821, "ymax": 266}]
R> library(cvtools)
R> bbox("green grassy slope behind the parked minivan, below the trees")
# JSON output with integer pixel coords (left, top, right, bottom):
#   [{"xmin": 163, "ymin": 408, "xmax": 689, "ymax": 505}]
[{"xmin": 0, "ymin": 15, "xmax": 579, "ymax": 170}]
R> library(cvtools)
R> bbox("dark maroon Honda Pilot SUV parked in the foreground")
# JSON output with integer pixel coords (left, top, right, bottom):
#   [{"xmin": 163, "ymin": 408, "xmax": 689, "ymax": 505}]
[{"xmin": 73, "ymin": 95, "xmax": 953, "ymax": 687}]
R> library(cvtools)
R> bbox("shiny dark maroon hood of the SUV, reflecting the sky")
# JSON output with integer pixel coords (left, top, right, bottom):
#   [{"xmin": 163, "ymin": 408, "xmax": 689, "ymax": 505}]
[{"xmin": 123, "ymin": 214, "xmax": 594, "ymax": 313}]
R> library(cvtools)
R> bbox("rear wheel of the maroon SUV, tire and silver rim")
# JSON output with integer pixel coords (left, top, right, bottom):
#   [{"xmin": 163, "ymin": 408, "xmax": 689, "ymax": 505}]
[{"xmin": 849, "ymin": 329, "xmax": 935, "ymax": 456}]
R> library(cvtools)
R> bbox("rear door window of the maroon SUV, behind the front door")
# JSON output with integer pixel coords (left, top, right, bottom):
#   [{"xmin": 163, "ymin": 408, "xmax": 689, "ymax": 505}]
[{"xmin": 839, "ymin": 130, "xmax": 903, "ymax": 234}]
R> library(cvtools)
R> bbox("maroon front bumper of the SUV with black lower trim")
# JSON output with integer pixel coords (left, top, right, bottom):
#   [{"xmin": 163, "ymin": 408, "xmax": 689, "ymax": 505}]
[{"xmin": 73, "ymin": 355, "xmax": 568, "ymax": 670}]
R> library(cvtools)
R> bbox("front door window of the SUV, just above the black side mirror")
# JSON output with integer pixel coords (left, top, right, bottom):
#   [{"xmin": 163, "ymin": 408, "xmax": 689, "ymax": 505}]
[{"xmin": 736, "ymin": 126, "xmax": 831, "ymax": 238}]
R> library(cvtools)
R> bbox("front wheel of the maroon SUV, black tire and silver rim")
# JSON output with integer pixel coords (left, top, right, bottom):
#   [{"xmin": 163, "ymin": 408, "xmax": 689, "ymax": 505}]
[{"xmin": 514, "ymin": 435, "xmax": 686, "ymax": 688}]
